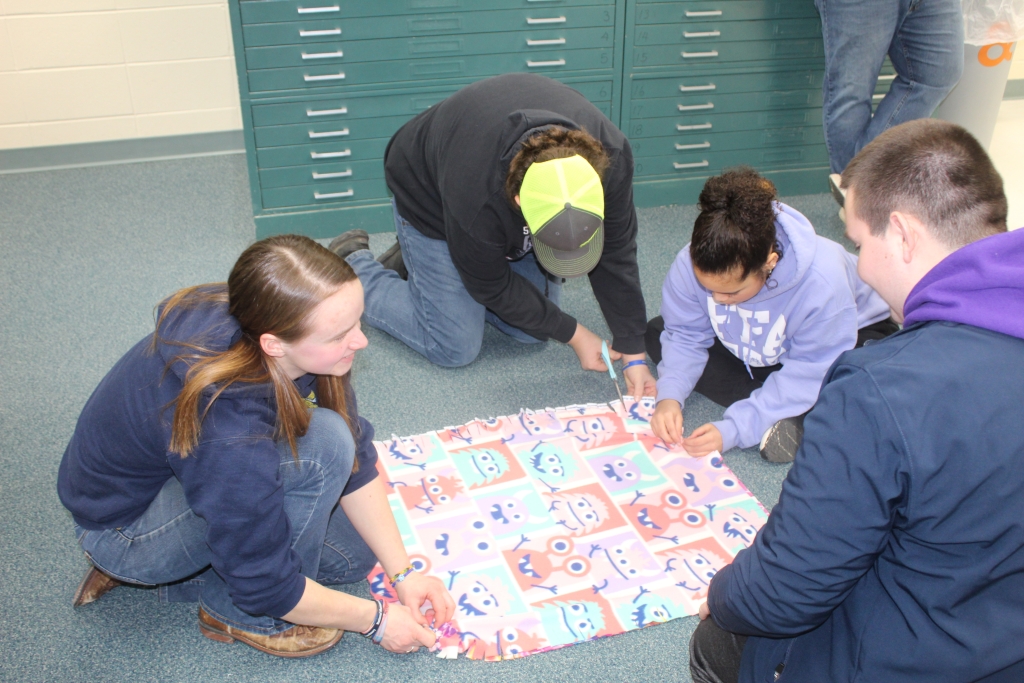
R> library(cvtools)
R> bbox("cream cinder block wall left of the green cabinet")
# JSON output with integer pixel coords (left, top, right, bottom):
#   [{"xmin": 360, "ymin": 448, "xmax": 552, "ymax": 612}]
[{"xmin": 0, "ymin": 0, "xmax": 242, "ymax": 150}]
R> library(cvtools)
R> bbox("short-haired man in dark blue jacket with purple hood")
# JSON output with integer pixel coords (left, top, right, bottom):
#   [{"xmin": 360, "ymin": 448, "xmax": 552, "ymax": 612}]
[{"xmin": 690, "ymin": 119, "xmax": 1024, "ymax": 683}]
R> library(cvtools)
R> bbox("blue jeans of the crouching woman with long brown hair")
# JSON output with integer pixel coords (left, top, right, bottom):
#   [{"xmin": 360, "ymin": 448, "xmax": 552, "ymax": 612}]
[{"xmin": 75, "ymin": 409, "xmax": 377, "ymax": 635}]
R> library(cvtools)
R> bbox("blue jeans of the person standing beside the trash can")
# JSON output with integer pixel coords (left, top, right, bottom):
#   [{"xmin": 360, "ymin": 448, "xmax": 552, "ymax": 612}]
[{"xmin": 815, "ymin": 0, "xmax": 964, "ymax": 173}]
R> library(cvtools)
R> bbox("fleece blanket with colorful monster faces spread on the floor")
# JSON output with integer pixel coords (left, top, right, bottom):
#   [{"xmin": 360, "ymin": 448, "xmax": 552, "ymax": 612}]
[{"xmin": 369, "ymin": 397, "xmax": 767, "ymax": 661}]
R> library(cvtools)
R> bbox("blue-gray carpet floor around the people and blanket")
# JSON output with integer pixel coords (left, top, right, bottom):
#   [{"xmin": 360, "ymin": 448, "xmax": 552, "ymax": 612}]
[{"xmin": 0, "ymin": 156, "xmax": 849, "ymax": 683}]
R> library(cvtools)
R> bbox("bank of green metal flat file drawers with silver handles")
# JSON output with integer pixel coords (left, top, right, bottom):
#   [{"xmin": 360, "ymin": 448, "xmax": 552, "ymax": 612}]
[{"xmin": 230, "ymin": 0, "xmax": 828, "ymax": 238}]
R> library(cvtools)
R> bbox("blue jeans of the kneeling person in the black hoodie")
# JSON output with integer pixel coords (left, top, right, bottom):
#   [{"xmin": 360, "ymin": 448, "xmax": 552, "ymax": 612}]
[{"xmin": 346, "ymin": 201, "xmax": 562, "ymax": 368}]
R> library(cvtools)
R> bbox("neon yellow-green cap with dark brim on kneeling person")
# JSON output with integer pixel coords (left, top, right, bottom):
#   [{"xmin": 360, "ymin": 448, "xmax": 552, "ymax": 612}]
[{"xmin": 519, "ymin": 155, "xmax": 604, "ymax": 278}]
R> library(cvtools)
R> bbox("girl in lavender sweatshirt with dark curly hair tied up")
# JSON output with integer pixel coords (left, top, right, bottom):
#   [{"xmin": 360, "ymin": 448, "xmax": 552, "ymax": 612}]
[{"xmin": 646, "ymin": 168, "xmax": 898, "ymax": 462}]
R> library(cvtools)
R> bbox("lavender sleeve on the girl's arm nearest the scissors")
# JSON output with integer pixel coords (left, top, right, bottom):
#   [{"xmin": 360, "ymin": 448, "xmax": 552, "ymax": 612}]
[{"xmin": 657, "ymin": 250, "xmax": 715, "ymax": 405}]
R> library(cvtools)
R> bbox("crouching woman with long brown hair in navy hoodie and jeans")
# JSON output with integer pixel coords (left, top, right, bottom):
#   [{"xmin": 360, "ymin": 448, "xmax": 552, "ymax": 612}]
[{"xmin": 57, "ymin": 236, "xmax": 455, "ymax": 657}]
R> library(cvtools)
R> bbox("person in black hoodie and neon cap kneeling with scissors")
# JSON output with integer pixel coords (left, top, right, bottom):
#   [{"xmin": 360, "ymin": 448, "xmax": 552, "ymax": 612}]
[{"xmin": 331, "ymin": 74, "xmax": 654, "ymax": 396}]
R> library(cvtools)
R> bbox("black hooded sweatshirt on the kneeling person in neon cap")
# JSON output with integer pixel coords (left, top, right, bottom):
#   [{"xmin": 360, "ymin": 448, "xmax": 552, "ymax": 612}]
[{"xmin": 384, "ymin": 74, "xmax": 647, "ymax": 353}]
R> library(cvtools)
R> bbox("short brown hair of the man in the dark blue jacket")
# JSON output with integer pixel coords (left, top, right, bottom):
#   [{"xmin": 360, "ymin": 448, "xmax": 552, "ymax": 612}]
[{"xmin": 843, "ymin": 119, "xmax": 1007, "ymax": 249}]
